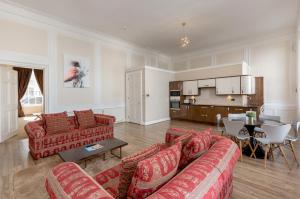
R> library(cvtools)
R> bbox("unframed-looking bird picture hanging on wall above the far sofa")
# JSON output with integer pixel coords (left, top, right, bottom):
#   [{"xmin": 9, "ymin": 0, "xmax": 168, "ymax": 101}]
[{"xmin": 64, "ymin": 55, "xmax": 90, "ymax": 88}]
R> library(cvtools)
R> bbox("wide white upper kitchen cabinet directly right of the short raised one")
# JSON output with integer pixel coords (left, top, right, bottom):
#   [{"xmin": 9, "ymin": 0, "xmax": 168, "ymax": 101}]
[{"xmin": 216, "ymin": 76, "xmax": 241, "ymax": 95}]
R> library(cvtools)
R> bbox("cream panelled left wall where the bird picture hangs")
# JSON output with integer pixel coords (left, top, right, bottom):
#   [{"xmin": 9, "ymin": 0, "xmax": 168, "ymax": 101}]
[{"xmin": 0, "ymin": 3, "xmax": 171, "ymax": 121}]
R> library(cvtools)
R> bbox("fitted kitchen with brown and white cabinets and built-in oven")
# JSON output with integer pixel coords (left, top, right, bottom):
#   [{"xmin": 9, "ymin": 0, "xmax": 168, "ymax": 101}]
[{"xmin": 169, "ymin": 75, "xmax": 264, "ymax": 124}]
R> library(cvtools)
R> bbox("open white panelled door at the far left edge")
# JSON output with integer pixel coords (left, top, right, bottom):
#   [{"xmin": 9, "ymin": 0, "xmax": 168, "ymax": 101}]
[{"xmin": 0, "ymin": 66, "xmax": 18, "ymax": 142}]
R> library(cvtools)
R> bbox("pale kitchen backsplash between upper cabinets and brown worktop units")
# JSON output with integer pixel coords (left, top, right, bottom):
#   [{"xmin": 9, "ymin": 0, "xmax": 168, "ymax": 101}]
[{"xmin": 186, "ymin": 88, "xmax": 247, "ymax": 106}]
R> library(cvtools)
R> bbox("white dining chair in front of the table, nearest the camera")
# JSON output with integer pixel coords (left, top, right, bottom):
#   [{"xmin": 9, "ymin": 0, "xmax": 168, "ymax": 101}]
[{"xmin": 250, "ymin": 124, "xmax": 291, "ymax": 169}]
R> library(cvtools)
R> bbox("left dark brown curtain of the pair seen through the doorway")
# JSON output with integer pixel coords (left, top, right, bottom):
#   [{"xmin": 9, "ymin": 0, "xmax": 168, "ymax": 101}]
[{"xmin": 13, "ymin": 67, "xmax": 32, "ymax": 117}]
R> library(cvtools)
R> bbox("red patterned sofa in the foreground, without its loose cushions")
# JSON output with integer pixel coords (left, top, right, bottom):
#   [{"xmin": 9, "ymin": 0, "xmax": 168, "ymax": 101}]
[{"xmin": 45, "ymin": 128, "xmax": 240, "ymax": 199}]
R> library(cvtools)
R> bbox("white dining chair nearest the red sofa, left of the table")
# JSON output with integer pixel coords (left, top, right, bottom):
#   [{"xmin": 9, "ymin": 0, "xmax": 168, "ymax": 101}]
[{"xmin": 223, "ymin": 118, "xmax": 253, "ymax": 161}]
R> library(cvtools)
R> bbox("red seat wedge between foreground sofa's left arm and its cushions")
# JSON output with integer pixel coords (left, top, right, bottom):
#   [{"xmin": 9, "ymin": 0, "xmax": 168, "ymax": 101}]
[{"xmin": 94, "ymin": 164, "xmax": 120, "ymax": 198}]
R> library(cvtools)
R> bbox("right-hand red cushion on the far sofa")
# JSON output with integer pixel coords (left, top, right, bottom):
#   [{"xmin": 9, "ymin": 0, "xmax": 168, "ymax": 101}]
[{"xmin": 74, "ymin": 109, "xmax": 96, "ymax": 129}]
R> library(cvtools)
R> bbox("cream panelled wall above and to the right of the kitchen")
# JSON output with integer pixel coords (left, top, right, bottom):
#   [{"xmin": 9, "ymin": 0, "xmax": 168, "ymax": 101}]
[{"xmin": 172, "ymin": 33, "xmax": 297, "ymax": 121}]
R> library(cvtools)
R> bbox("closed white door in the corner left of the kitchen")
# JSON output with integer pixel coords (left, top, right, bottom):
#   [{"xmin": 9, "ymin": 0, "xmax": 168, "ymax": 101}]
[{"xmin": 126, "ymin": 70, "xmax": 143, "ymax": 124}]
